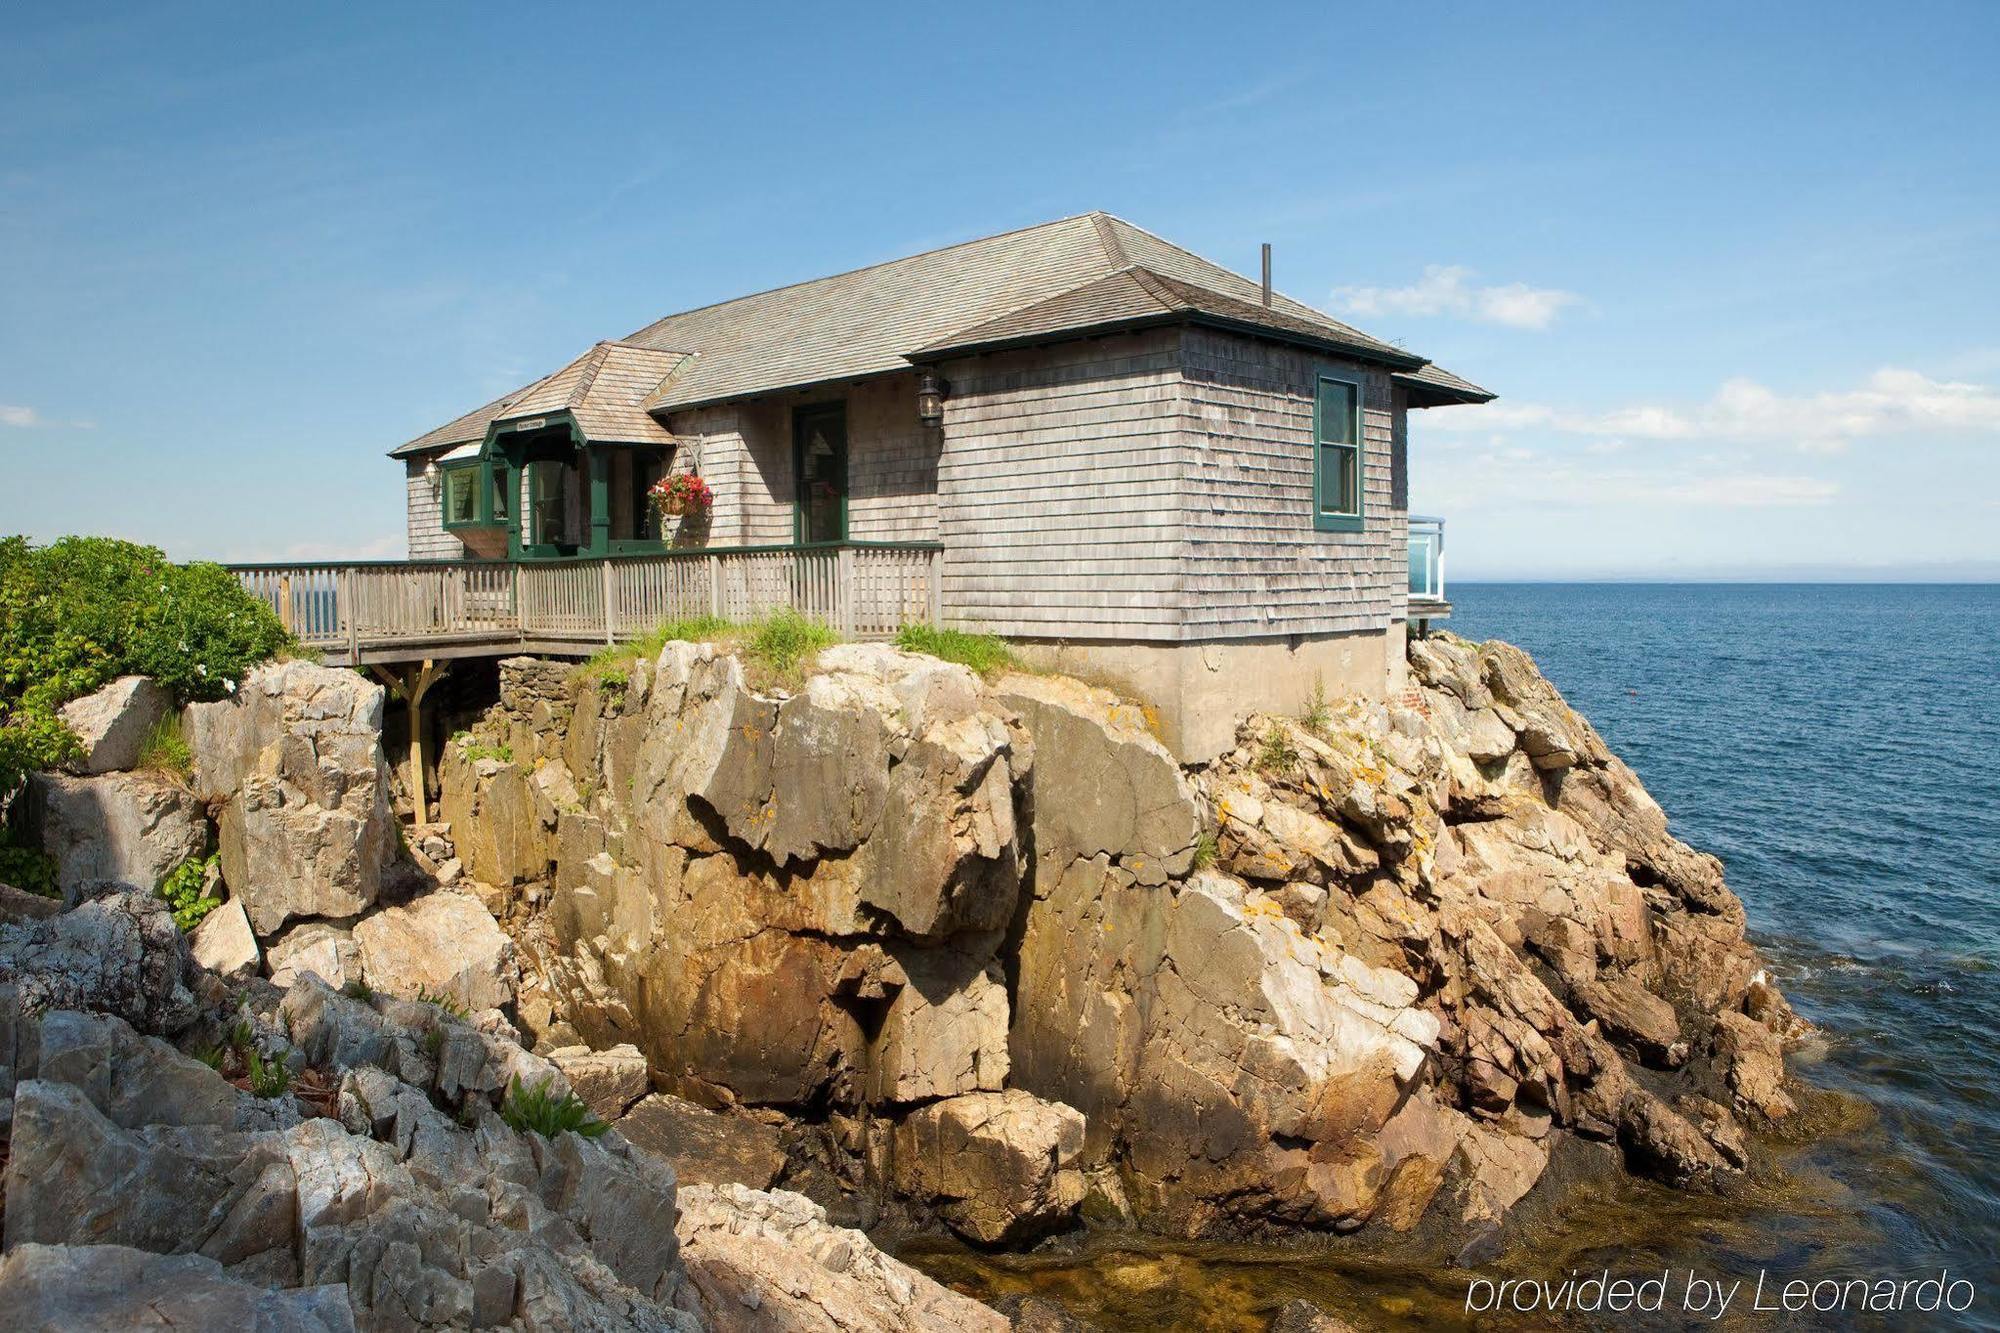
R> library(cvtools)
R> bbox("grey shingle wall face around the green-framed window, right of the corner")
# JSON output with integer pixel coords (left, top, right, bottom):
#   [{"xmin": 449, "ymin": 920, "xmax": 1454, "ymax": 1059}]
[{"xmin": 1182, "ymin": 328, "xmax": 1408, "ymax": 638}]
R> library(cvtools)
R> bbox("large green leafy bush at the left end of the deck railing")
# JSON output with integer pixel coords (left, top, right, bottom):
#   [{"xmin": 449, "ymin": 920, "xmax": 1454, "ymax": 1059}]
[{"xmin": 0, "ymin": 536, "xmax": 294, "ymax": 799}]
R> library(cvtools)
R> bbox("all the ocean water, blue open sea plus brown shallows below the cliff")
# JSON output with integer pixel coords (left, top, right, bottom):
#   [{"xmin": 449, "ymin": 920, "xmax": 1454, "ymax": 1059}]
[{"xmin": 910, "ymin": 582, "xmax": 2000, "ymax": 1333}]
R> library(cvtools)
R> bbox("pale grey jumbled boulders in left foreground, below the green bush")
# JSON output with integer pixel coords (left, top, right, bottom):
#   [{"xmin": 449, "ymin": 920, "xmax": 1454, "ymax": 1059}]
[{"xmin": 0, "ymin": 662, "xmax": 1006, "ymax": 1333}]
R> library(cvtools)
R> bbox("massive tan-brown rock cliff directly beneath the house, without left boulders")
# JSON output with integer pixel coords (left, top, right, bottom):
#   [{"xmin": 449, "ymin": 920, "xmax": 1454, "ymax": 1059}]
[{"xmin": 444, "ymin": 636, "xmax": 1798, "ymax": 1245}]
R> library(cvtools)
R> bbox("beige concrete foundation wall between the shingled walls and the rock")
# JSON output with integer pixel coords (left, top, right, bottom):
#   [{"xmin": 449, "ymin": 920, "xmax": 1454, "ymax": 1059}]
[{"xmin": 1016, "ymin": 622, "xmax": 1408, "ymax": 765}]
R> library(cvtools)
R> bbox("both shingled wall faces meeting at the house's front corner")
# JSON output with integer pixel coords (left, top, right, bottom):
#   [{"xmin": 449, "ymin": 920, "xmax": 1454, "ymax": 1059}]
[{"xmin": 938, "ymin": 328, "xmax": 1408, "ymax": 642}]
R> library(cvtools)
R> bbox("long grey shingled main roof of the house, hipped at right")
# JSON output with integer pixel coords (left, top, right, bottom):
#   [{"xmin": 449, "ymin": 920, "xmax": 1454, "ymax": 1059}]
[{"xmin": 394, "ymin": 212, "xmax": 1490, "ymax": 454}]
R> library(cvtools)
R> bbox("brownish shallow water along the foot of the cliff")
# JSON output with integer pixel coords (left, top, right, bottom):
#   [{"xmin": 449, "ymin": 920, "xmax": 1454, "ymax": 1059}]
[{"xmin": 896, "ymin": 1093, "xmax": 1922, "ymax": 1333}]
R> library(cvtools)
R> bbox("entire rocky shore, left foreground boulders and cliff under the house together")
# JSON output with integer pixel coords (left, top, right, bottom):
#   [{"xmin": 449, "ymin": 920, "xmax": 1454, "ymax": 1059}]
[{"xmin": 0, "ymin": 636, "xmax": 1802, "ymax": 1329}]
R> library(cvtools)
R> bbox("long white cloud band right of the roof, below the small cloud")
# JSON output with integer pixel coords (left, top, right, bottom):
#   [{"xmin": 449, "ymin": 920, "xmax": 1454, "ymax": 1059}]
[{"xmin": 1426, "ymin": 366, "xmax": 2000, "ymax": 452}]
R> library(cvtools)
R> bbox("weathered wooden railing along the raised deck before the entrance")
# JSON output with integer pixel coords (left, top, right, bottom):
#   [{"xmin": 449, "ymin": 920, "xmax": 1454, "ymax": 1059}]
[{"xmin": 230, "ymin": 542, "xmax": 940, "ymax": 662}]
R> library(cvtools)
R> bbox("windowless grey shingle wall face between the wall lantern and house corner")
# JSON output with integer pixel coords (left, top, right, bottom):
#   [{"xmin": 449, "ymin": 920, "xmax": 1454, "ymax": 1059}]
[{"xmin": 938, "ymin": 330, "xmax": 1184, "ymax": 640}]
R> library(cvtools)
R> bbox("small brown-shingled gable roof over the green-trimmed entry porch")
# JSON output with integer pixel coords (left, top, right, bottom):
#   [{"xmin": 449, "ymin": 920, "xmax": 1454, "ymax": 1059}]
[{"xmin": 394, "ymin": 342, "xmax": 688, "ymax": 456}]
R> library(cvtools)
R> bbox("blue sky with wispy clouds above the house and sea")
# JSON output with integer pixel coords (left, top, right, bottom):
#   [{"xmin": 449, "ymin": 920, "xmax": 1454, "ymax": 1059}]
[{"xmin": 0, "ymin": 2, "xmax": 2000, "ymax": 578}]
